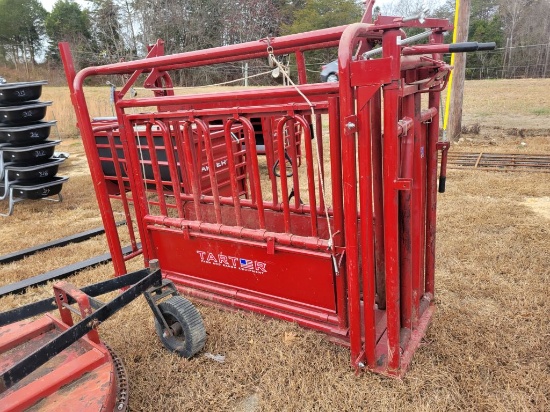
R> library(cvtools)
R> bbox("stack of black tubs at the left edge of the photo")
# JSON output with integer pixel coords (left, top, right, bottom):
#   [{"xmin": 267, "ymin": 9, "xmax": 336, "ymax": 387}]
[{"xmin": 0, "ymin": 81, "xmax": 68, "ymax": 216}]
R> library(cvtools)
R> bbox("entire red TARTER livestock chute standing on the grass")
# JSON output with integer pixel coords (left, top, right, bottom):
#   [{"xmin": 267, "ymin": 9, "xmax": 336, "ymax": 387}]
[{"xmin": 60, "ymin": 10, "xmax": 458, "ymax": 376}]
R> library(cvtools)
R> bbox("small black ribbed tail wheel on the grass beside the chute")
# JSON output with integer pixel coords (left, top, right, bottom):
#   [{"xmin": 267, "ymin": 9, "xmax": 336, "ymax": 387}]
[{"xmin": 155, "ymin": 296, "xmax": 206, "ymax": 358}]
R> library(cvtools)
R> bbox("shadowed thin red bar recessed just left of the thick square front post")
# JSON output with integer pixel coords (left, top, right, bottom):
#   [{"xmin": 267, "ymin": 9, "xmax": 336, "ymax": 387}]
[{"xmin": 370, "ymin": 90, "xmax": 386, "ymax": 309}]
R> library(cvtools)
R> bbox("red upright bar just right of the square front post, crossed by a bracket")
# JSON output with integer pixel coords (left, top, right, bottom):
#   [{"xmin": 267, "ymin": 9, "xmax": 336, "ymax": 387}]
[{"xmin": 399, "ymin": 100, "xmax": 414, "ymax": 330}]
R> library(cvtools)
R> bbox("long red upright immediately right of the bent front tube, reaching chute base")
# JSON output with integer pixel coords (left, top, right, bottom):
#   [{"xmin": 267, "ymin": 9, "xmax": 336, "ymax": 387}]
[{"xmin": 357, "ymin": 89, "xmax": 376, "ymax": 368}]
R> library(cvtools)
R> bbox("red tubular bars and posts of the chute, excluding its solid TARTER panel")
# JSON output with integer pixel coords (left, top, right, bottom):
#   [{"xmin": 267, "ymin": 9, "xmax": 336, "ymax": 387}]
[{"xmin": 62, "ymin": 16, "xmax": 458, "ymax": 376}]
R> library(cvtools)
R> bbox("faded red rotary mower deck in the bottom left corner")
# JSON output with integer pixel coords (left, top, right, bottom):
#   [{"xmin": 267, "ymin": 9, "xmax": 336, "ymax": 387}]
[{"xmin": 0, "ymin": 315, "xmax": 118, "ymax": 412}]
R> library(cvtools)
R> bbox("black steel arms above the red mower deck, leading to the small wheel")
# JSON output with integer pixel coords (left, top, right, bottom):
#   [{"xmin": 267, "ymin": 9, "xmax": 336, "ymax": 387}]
[{"xmin": 0, "ymin": 261, "xmax": 177, "ymax": 394}]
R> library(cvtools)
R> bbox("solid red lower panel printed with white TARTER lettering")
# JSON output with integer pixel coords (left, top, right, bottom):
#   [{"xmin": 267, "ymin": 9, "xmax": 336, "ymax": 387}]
[{"xmin": 151, "ymin": 228, "xmax": 336, "ymax": 311}]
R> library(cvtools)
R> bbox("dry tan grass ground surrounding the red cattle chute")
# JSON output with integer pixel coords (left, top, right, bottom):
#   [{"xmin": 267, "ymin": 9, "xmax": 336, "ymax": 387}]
[{"xmin": 0, "ymin": 80, "xmax": 550, "ymax": 412}]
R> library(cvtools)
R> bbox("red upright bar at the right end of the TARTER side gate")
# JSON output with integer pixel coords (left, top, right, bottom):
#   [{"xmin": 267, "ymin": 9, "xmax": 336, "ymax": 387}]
[{"xmin": 328, "ymin": 97, "xmax": 348, "ymax": 328}]
